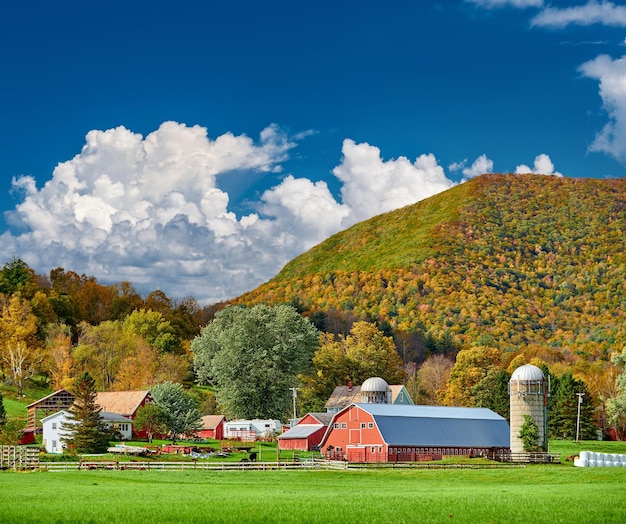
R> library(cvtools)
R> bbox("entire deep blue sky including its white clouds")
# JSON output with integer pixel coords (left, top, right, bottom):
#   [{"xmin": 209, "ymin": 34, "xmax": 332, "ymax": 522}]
[{"xmin": 0, "ymin": 0, "xmax": 626, "ymax": 303}]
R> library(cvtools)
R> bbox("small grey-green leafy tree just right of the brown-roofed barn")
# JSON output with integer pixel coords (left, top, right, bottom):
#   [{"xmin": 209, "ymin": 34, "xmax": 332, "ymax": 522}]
[{"xmin": 150, "ymin": 382, "xmax": 201, "ymax": 443}]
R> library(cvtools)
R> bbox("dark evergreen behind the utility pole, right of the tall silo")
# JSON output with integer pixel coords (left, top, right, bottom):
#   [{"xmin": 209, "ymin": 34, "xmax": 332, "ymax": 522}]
[{"xmin": 548, "ymin": 372, "xmax": 595, "ymax": 440}]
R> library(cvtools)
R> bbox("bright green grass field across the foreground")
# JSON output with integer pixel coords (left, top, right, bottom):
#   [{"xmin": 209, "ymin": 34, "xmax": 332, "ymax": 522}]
[{"xmin": 0, "ymin": 466, "xmax": 626, "ymax": 524}]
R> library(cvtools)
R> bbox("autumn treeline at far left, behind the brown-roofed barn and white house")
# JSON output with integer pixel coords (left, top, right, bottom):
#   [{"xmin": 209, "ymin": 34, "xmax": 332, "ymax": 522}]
[{"xmin": 0, "ymin": 259, "xmax": 224, "ymax": 394}]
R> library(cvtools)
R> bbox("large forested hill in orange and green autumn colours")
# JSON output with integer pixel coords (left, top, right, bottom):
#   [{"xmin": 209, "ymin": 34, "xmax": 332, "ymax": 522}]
[{"xmin": 237, "ymin": 175, "xmax": 626, "ymax": 361}]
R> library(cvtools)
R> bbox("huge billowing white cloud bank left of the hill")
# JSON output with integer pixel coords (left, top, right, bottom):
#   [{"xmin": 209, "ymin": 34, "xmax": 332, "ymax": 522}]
[{"xmin": 0, "ymin": 122, "xmax": 453, "ymax": 303}]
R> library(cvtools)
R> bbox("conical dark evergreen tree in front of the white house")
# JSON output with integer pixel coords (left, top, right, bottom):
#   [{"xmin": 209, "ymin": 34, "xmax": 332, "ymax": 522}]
[{"xmin": 61, "ymin": 373, "xmax": 113, "ymax": 453}]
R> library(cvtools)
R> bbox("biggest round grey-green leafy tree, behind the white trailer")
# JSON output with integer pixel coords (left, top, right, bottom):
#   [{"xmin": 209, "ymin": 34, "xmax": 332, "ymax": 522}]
[{"xmin": 191, "ymin": 305, "xmax": 319, "ymax": 418}]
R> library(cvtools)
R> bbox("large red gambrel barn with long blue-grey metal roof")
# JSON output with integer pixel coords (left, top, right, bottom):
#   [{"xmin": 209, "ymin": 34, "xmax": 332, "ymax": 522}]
[{"xmin": 320, "ymin": 403, "xmax": 510, "ymax": 462}]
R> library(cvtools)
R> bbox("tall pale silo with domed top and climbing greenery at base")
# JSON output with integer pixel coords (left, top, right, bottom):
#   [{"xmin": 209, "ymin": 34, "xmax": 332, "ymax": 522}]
[{"xmin": 509, "ymin": 364, "xmax": 547, "ymax": 453}]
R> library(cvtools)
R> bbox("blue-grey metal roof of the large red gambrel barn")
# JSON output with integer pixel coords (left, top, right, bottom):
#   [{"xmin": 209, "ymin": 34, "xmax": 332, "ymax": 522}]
[{"xmin": 356, "ymin": 404, "xmax": 510, "ymax": 448}]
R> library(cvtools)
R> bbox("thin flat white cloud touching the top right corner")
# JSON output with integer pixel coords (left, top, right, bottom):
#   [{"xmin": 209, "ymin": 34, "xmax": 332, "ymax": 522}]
[{"xmin": 531, "ymin": 0, "xmax": 626, "ymax": 28}]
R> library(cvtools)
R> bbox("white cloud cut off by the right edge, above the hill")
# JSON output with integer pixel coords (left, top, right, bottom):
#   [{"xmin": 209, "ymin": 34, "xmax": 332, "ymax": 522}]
[{"xmin": 580, "ymin": 55, "xmax": 626, "ymax": 163}]
